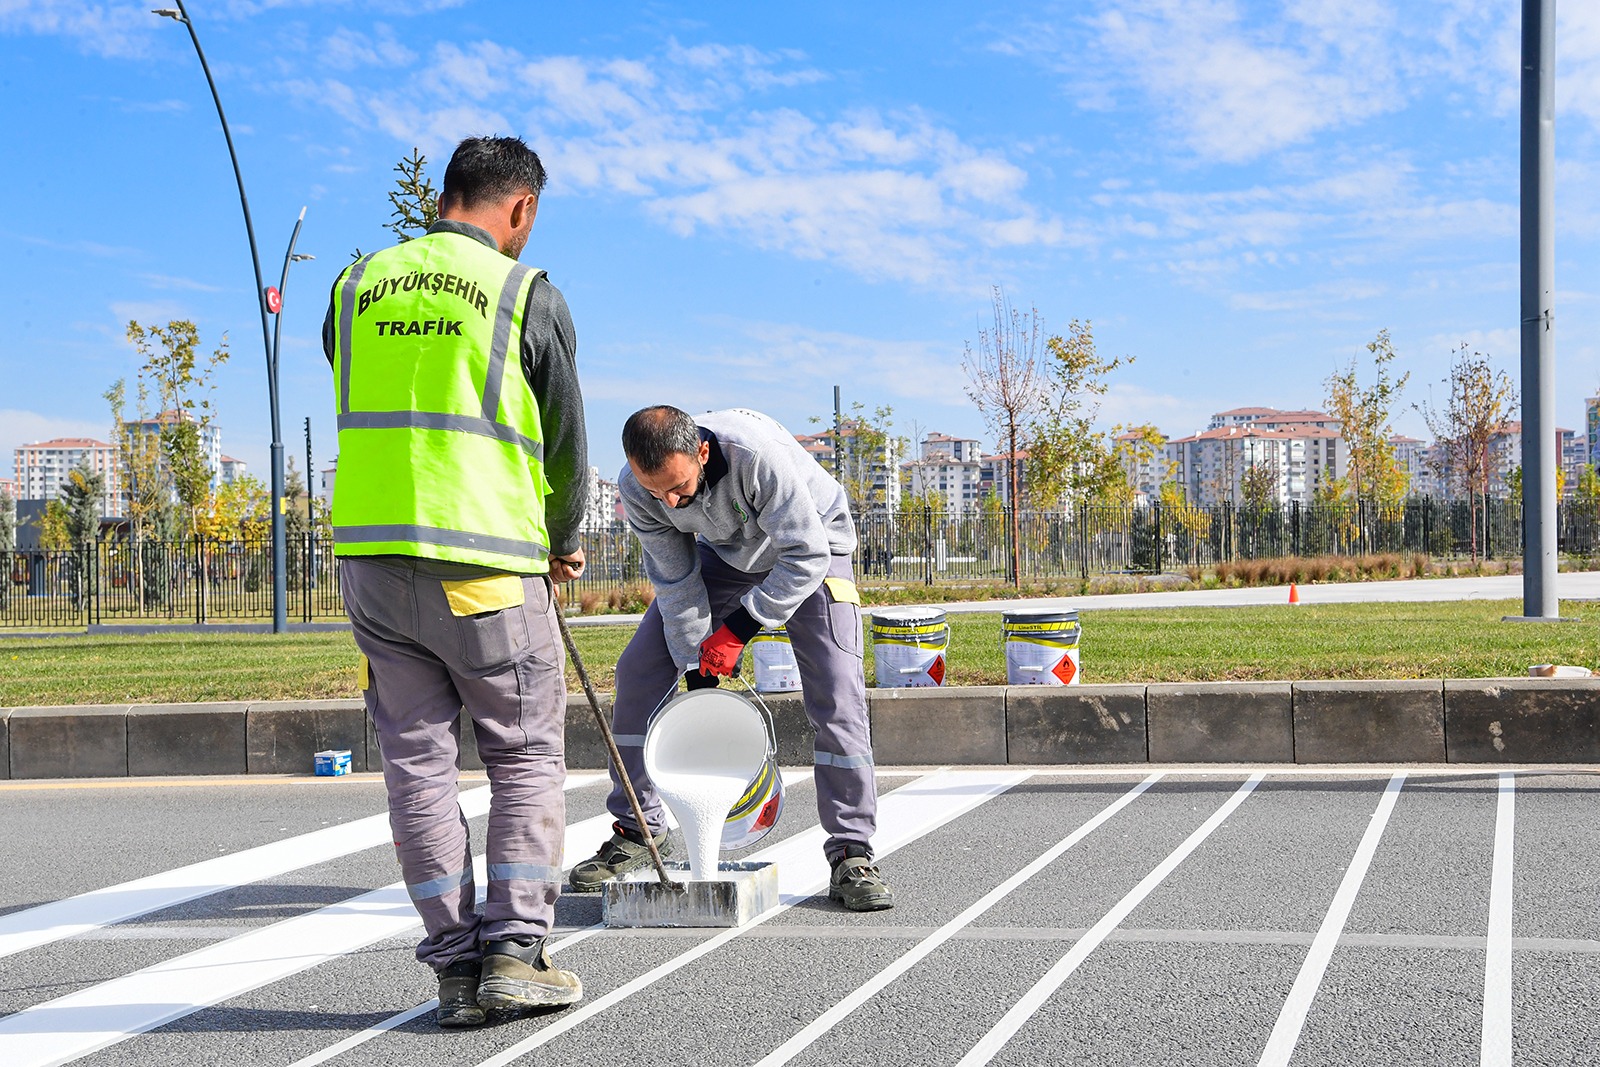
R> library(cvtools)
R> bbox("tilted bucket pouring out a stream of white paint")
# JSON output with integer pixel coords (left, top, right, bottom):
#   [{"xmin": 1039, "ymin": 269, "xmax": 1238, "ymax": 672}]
[{"xmin": 645, "ymin": 689, "xmax": 784, "ymax": 881}]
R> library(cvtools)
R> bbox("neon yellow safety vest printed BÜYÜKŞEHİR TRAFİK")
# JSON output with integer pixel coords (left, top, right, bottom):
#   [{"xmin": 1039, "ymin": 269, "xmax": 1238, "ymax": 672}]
[{"xmin": 333, "ymin": 234, "xmax": 549, "ymax": 573}]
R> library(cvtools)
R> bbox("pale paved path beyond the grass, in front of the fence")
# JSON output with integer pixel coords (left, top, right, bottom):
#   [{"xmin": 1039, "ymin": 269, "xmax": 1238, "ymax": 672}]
[{"xmin": 570, "ymin": 571, "xmax": 1600, "ymax": 625}]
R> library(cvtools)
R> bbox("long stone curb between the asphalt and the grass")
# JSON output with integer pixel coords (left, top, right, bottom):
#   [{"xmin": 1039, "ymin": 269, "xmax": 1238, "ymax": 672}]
[{"xmin": 0, "ymin": 678, "xmax": 1600, "ymax": 779}]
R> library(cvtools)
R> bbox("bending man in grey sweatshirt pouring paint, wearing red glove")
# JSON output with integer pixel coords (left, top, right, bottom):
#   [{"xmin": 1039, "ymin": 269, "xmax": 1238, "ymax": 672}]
[{"xmin": 570, "ymin": 405, "xmax": 894, "ymax": 912}]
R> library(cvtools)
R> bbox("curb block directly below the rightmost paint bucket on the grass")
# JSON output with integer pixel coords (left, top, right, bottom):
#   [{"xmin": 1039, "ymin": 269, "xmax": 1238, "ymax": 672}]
[{"xmin": 1000, "ymin": 685, "xmax": 1150, "ymax": 763}]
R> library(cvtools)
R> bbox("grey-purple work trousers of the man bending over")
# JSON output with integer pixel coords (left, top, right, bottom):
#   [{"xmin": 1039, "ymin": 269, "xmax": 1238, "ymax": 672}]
[{"xmin": 608, "ymin": 544, "xmax": 878, "ymax": 861}]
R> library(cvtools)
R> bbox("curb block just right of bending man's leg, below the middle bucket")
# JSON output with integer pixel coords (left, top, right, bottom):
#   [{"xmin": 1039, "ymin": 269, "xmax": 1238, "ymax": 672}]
[{"xmin": 867, "ymin": 685, "xmax": 1006, "ymax": 765}]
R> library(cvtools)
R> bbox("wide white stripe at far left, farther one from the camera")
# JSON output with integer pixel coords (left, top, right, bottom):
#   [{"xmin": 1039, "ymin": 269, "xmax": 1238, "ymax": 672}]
[{"xmin": 0, "ymin": 774, "xmax": 605, "ymax": 958}]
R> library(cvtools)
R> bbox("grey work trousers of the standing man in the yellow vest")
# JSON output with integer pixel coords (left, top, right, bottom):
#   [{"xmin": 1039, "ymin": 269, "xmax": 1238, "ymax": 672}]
[{"xmin": 339, "ymin": 557, "xmax": 566, "ymax": 971}]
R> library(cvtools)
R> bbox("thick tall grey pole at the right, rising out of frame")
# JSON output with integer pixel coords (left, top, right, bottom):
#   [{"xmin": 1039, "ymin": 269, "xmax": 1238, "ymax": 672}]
[{"xmin": 1522, "ymin": 0, "xmax": 1560, "ymax": 619}]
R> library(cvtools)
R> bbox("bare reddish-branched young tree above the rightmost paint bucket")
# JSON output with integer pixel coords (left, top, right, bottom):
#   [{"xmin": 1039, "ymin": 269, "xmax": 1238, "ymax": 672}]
[{"xmin": 962, "ymin": 286, "xmax": 1048, "ymax": 585}]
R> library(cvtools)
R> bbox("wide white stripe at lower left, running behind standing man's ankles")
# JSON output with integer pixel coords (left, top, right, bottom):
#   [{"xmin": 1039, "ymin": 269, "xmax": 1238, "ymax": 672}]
[{"xmin": 0, "ymin": 814, "xmax": 611, "ymax": 1067}]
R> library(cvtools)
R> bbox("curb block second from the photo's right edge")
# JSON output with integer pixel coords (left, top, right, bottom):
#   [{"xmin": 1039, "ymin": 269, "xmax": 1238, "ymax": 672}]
[{"xmin": 1294, "ymin": 680, "xmax": 1445, "ymax": 763}]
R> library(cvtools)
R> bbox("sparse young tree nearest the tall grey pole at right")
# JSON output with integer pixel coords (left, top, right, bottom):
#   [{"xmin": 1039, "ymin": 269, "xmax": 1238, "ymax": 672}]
[{"xmin": 1416, "ymin": 342, "xmax": 1517, "ymax": 563}]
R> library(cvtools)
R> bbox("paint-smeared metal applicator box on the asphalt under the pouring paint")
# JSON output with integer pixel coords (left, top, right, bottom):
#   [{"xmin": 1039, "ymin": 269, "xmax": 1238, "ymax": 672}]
[{"xmin": 600, "ymin": 862, "xmax": 778, "ymax": 926}]
